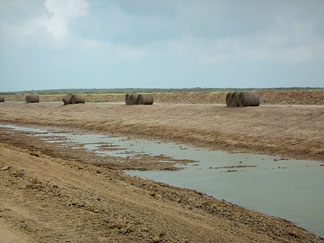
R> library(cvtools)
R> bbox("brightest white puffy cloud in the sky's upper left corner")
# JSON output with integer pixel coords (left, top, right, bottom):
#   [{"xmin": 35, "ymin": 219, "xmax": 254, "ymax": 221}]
[{"xmin": 0, "ymin": 0, "xmax": 89, "ymax": 44}]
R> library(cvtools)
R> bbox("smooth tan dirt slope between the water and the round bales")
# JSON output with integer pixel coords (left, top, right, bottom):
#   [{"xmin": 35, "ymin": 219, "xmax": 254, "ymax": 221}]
[{"xmin": 0, "ymin": 103, "xmax": 324, "ymax": 161}]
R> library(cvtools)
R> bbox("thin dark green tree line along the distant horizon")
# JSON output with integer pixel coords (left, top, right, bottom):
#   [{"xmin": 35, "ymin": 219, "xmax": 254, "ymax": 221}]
[{"xmin": 0, "ymin": 87, "xmax": 324, "ymax": 95}]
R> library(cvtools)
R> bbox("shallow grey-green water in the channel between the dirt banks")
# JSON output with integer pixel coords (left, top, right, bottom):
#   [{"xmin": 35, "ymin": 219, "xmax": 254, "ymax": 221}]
[{"xmin": 0, "ymin": 125, "xmax": 324, "ymax": 237}]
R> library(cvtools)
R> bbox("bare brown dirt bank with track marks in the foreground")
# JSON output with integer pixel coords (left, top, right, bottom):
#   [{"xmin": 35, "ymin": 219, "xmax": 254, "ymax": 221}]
[{"xmin": 0, "ymin": 131, "xmax": 323, "ymax": 242}]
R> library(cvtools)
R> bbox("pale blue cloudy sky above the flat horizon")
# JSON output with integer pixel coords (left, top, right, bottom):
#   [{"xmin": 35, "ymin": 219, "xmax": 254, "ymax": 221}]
[{"xmin": 0, "ymin": 0, "xmax": 324, "ymax": 92}]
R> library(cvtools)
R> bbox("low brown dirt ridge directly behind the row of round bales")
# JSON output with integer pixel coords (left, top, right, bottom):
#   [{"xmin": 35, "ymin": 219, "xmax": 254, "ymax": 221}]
[{"xmin": 6, "ymin": 90, "xmax": 324, "ymax": 105}]
